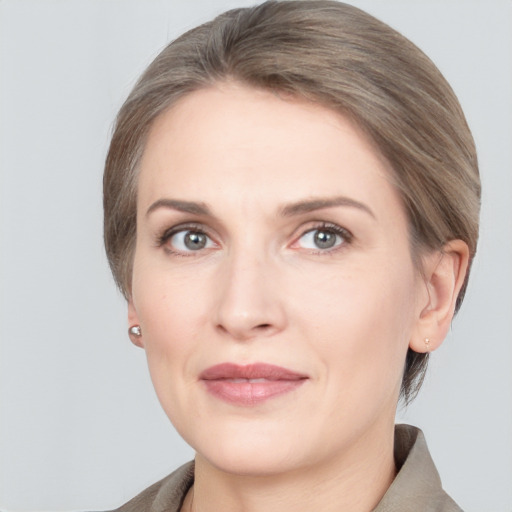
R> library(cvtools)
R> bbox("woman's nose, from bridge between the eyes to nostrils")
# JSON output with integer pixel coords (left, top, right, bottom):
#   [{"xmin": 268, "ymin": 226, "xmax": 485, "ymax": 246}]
[{"xmin": 215, "ymin": 250, "xmax": 286, "ymax": 341}]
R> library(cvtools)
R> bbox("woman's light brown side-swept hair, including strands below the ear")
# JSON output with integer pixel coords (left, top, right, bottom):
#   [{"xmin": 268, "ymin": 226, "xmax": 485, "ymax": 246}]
[{"xmin": 104, "ymin": 0, "xmax": 480, "ymax": 401}]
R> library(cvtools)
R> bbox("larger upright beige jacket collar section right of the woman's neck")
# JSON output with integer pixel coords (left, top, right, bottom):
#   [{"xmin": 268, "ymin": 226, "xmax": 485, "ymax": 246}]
[{"xmin": 373, "ymin": 425, "xmax": 462, "ymax": 512}]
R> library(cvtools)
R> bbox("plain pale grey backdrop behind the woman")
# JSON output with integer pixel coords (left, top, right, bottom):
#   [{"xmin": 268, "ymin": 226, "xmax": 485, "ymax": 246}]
[{"xmin": 0, "ymin": 0, "xmax": 512, "ymax": 512}]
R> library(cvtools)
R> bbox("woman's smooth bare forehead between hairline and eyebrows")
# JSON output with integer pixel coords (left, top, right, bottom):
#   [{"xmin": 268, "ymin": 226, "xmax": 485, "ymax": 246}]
[{"xmin": 139, "ymin": 84, "xmax": 400, "ymax": 216}]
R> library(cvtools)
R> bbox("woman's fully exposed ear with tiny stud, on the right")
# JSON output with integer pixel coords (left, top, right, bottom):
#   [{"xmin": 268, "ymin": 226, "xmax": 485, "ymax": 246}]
[{"xmin": 409, "ymin": 240, "xmax": 469, "ymax": 352}]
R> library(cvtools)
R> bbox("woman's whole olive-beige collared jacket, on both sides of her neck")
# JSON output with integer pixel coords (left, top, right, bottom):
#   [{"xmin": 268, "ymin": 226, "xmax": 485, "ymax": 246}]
[{"xmin": 113, "ymin": 425, "xmax": 462, "ymax": 512}]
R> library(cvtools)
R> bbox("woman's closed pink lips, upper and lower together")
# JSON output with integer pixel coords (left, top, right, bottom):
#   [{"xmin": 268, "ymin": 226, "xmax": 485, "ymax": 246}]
[{"xmin": 199, "ymin": 363, "xmax": 308, "ymax": 406}]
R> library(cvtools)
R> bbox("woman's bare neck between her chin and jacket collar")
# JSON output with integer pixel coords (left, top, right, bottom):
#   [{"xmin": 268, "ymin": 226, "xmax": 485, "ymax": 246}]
[{"xmin": 189, "ymin": 422, "xmax": 396, "ymax": 512}]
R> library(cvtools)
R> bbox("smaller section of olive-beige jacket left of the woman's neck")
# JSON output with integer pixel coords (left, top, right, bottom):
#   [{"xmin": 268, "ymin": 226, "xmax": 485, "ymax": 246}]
[{"xmin": 106, "ymin": 462, "xmax": 194, "ymax": 512}]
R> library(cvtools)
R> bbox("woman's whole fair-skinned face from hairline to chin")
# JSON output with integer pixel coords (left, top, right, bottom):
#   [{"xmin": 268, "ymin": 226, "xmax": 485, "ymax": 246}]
[{"xmin": 129, "ymin": 84, "xmax": 425, "ymax": 474}]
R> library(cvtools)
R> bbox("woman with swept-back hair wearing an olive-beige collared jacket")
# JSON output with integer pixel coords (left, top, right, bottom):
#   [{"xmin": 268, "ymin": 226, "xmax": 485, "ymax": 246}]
[{"xmin": 104, "ymin": 1, "xmax": 480, "ymax": 512}]
